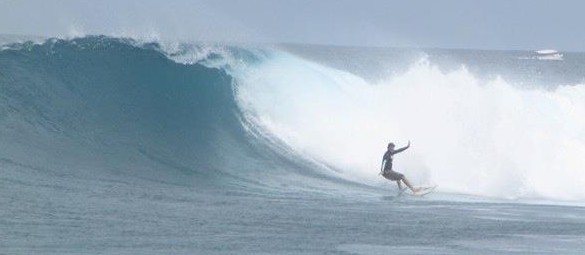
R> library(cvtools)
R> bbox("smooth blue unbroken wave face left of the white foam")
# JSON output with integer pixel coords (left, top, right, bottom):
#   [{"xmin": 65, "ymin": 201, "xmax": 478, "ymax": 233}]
[{"xmin": 0, "ymin": 37, "xmax": 338, "ymax": 191}]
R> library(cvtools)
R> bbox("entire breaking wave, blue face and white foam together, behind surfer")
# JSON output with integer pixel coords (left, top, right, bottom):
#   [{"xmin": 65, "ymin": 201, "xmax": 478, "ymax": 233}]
[{"xmin": 0, "ymin": 37, "xmax": 585, "ymax": 201}]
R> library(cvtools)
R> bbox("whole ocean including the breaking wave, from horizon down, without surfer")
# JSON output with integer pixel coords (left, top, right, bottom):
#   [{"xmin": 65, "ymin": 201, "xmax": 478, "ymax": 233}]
[{"xmin": 0, "ymin": 36, "xmax": 585, "ymax": 255}]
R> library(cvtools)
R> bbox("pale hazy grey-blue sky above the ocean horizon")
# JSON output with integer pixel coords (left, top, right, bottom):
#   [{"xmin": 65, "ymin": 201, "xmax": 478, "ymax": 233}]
[{"xmin": 0, "ymin": 0, "xmax": 585, "ymax": 51}]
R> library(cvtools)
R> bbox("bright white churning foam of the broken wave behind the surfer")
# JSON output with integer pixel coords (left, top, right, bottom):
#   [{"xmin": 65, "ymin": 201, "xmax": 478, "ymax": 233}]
[{"xmin": 236, "ymin": 50, "xmax": 585, "ymax": 200}]
